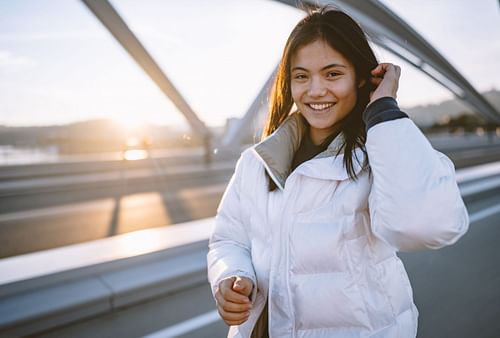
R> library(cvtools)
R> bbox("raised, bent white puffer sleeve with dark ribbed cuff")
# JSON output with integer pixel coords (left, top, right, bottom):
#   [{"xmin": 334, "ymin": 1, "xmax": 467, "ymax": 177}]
[{"xmin": 363, "ymin": 97, "xmax": 469, "ymax": 251}]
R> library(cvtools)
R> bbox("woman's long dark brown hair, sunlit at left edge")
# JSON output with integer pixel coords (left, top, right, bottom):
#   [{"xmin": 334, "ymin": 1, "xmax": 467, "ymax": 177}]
[{"xmin": 262, "ymin": 7, "xmax": 378, "ymax": 191}]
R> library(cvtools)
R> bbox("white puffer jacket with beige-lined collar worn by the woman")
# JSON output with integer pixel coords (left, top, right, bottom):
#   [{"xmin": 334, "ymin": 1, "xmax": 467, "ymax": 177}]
[{"xmin": 208, "ymin": 109, "xmax": 468, "ymax": 338}]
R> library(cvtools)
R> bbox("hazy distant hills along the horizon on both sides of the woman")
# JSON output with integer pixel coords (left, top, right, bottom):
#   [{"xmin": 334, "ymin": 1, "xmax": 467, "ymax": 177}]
[{"xmin": 0, "ymin": 90, "xmax": 500, "ymax": 153}]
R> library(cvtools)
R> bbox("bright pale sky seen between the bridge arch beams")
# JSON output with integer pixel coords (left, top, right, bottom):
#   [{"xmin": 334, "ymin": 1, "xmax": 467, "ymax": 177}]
[{"xmin": 0, "ymin": 0, "xmax": 500, "ymax": 126}]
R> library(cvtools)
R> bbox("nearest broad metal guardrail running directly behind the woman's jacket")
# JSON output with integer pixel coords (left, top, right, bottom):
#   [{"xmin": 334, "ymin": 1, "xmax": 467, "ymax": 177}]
[{"xmin": 0, "ymin": 162, "xmax": 500, "ymax": 337}]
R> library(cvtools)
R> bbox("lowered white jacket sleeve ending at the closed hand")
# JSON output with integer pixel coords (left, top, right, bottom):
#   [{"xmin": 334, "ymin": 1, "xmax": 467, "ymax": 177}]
[{"xmin": 207, "ymin": 154, "xmax": 257, "ymax": 300}]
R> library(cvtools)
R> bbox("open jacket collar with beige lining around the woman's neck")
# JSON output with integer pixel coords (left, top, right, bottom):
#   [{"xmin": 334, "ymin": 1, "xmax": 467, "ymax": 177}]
[{"xmin": 253, "ymin": 113, "xmax": 364, "ymax": 189}]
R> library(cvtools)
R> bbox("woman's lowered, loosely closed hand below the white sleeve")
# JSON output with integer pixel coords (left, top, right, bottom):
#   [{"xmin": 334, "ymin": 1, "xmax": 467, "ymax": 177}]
[{"xmin": 215, "ymin": 277, "xmax": 253, "ymax": 325}]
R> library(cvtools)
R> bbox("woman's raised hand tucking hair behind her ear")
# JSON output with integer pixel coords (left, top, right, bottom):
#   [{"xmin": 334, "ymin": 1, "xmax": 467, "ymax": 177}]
[{"xmin": 368, "ymin": 63, "xmax": 401, "ymax": 104}]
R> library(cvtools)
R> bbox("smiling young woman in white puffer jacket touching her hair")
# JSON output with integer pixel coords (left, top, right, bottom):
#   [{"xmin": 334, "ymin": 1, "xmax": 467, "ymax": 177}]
[{"xmin": 208, "ymin": 9, "xmax": 468, "ymax": 338}]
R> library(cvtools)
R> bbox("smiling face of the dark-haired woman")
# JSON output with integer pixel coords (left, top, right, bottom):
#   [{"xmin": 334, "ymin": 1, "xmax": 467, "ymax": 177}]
[{"xmin": 290, "ymin": 40, "xmax": 358, "ymax": 144}]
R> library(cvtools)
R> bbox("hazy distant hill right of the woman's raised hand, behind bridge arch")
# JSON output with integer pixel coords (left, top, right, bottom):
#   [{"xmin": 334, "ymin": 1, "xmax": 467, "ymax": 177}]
[{"xmin": 402, "ymin": 89, "xmax": 500, "ymax": 127}]
